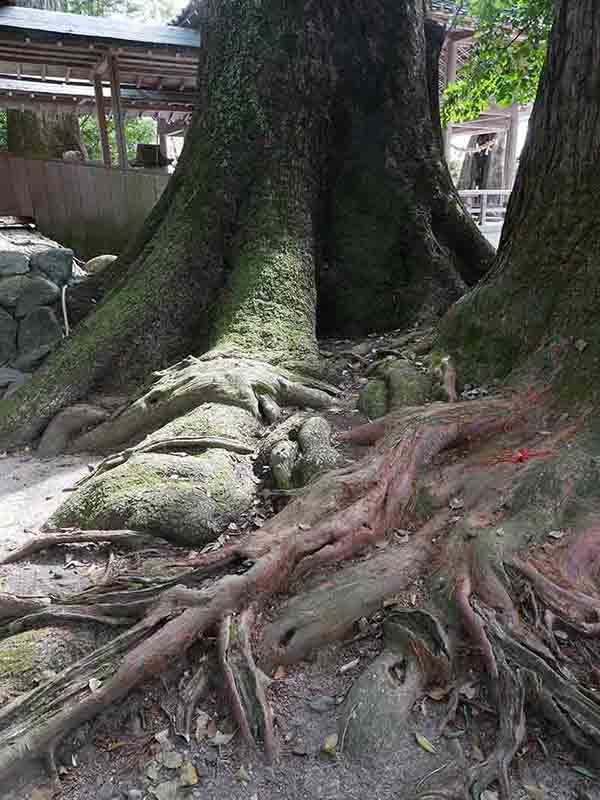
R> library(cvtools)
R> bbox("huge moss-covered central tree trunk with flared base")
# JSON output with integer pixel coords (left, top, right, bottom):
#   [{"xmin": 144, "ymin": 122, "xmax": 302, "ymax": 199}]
[{"xmin": 0, "ymin": 0, "xmax": 491, "ymax": 445}]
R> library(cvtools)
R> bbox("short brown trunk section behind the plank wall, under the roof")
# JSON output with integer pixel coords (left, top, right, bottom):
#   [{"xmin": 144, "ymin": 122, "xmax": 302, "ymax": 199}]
[{"xmin": 6, "ymin": 111, "xmax": 86, "ymax": 158}]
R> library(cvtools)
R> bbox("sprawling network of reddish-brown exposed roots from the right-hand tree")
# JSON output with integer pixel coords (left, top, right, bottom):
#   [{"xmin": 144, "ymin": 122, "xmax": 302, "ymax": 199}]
[{"xmin": 0, "ymin": 396, "xmax": 600, "ymax": 800}]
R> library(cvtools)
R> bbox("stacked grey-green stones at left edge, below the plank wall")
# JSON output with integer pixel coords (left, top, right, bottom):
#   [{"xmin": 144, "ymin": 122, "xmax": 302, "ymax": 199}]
[{"xmin": 0, "ymin": 239, "xmax": 73, "ymax": 396}]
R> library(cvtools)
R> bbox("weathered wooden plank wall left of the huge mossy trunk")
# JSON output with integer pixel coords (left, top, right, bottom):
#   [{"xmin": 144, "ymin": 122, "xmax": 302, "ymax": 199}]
[{"xmin": 0, "ymin": 153, "xmax": 169, "ymax": 259}]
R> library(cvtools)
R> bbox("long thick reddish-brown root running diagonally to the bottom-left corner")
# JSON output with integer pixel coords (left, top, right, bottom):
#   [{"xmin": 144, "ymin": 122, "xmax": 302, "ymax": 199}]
[{"xmin": 0, "ymin": 400, "xmax": 552, "ymax": 780}]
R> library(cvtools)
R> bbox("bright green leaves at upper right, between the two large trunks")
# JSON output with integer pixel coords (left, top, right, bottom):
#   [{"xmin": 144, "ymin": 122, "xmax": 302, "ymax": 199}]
[{"xmin": 442, "ymin": 0, "xmax": 553, "ymax": 123}]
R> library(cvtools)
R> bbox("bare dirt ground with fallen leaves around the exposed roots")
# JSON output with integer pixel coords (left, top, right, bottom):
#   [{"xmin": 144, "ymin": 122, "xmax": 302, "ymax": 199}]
[{"xmin": 0, "ymin": 336, "xmax": 600, "ymax": 800}]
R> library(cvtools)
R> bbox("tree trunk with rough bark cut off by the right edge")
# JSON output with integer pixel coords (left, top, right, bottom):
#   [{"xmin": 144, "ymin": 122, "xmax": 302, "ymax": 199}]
[{"xmin": 442, "ymin": 0, "xmax": 600, "ymax": 400}]
